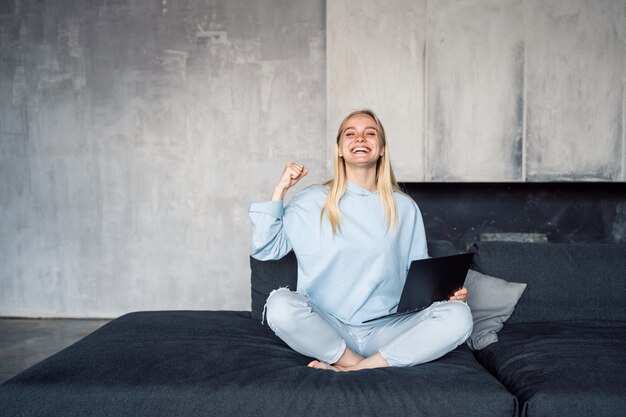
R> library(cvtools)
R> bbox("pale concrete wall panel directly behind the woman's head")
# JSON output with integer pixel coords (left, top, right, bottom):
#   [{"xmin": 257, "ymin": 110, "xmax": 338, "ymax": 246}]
[{"xmin": 326, "ymin": 0, "xmax": 426, "ymax": 181}]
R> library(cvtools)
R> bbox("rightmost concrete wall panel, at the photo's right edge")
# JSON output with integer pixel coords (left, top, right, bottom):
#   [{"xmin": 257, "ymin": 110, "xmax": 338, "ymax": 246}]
[{"xmin": 525, "ymin": 0, "xmax": 626, "ymax": 181}]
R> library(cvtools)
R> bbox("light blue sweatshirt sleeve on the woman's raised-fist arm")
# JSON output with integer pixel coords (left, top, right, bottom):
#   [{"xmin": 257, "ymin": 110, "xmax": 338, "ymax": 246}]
[{"xmin": 249, "ymin": 201, "xmax": 292, "ymax": 261}]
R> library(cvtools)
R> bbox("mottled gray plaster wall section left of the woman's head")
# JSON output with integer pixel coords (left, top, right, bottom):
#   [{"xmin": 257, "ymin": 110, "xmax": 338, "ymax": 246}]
[{"xmin": 0, "ymin": 0, "xmax": 326, "ymax": 317}]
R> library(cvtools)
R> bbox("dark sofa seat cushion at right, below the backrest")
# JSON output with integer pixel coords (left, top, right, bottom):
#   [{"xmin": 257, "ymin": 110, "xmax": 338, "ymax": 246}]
[{"xmin": 476, "ymin": 321, "xmax": 626, "ymax": 417}]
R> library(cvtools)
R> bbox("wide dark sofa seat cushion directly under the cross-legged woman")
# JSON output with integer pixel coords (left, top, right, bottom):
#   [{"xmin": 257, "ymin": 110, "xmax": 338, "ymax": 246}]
[{"xmin": 0, "ymin": 311, "xmax": 517, "ymax": 417}]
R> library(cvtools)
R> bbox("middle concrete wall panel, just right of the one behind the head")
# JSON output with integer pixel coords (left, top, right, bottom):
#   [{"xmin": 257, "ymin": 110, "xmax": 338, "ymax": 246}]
[{"xmin": 426, "ymin": 0, "xmax": 524, "ymax": 181}]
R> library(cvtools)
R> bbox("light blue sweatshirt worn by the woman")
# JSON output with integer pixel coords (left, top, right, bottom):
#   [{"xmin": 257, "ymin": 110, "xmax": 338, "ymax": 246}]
[{"xmin": 249, "ymin": 181, "xmax": 428, "ymax": 324}]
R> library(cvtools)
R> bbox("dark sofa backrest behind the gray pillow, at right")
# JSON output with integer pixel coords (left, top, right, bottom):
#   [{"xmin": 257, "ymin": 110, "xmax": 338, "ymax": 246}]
[{"xmin": 471, "ymin": 242, "xmax": 626, "ymax": 323}]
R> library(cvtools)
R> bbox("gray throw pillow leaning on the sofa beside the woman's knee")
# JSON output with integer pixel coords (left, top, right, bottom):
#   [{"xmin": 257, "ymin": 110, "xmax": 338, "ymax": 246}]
[{"xmin": 465, "ymin": 269, "xmax": 526, "ymax": 350}]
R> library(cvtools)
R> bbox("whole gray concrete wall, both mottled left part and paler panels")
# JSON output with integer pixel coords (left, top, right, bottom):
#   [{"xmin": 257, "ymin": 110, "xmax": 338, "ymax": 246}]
[{"xmin": 0, "ymin": 0, "xmax": 626, "ymax": 317}]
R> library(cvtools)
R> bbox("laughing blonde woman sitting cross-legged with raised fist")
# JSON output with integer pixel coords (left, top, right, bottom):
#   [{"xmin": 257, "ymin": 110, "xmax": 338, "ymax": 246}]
[{"xmin": 250, "ymin": 110, "xmax": 472, "ymax": 371}]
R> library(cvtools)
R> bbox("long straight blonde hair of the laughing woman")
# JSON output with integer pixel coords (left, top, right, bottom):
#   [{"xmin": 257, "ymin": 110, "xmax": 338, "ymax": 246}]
[{"xmin": 320, "ymin": 109, "xmax": 401, "ymax": 235}]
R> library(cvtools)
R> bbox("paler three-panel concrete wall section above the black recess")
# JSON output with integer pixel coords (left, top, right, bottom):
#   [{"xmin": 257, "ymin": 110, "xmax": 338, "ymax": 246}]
[{"xmin": 327, "ymin": 0, "xmax": 626, "ymax": 181}]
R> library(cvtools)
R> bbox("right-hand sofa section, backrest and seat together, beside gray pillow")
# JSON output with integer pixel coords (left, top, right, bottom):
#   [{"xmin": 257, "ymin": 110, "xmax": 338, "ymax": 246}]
[{"xmin": 473, "ymin": 242, "xmax": 626, "ymax": 417}]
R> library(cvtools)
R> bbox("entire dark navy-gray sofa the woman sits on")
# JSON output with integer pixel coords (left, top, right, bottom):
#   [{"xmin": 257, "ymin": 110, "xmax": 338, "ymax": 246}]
[{"xmin": 0, "ymin": 242, "xmax": 626, "ymax": 417}]
